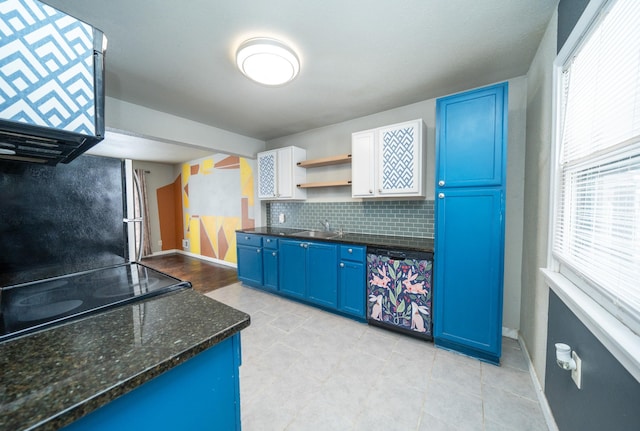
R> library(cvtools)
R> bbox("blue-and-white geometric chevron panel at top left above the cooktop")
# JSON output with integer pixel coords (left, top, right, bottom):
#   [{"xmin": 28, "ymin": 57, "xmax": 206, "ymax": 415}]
[{"xmin": 0, "ymin": 0, "xmax": 96, "ymax": 135}]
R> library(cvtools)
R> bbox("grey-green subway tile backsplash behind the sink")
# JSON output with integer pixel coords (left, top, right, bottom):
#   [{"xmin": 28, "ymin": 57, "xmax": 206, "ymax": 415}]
[{"xmin": 266, "ymin": 200, "xmax": 434, "ymax": 238}]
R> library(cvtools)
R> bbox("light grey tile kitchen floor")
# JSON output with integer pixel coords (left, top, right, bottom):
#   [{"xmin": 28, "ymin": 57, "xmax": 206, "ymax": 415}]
[{"xmin": 207, "ymin": 283, "xmax": 548, "ymax": 431}]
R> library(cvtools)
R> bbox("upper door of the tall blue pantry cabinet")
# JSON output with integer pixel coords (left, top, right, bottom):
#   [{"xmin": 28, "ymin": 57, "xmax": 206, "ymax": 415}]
[{"xmin": 436, "ymin": 84, "xmax": 507, "ymax": 187}]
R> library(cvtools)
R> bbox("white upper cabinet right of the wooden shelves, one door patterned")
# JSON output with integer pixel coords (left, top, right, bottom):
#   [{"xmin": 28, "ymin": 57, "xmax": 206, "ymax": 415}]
[{"xmin": 351, "ymin": 119, "xmax": 426, "ymax": 198}]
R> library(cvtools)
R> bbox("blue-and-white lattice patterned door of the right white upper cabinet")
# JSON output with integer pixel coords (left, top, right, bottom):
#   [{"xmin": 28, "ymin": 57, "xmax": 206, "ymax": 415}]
[{"xmin": 378, "ymin": 120, "xmax": 423, "ymax": 196}]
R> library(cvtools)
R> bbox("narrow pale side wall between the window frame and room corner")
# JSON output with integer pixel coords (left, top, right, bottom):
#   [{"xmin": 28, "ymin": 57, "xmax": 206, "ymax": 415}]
[{"xmin": 520, "ymin": 12, "xmax": 558, "ymax": 386}]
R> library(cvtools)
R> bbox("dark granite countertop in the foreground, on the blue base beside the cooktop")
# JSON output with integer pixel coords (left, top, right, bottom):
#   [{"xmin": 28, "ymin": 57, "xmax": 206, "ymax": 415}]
[{"xmin": 0, "ymin": 289, "xmax": 250, "ymax": 431}]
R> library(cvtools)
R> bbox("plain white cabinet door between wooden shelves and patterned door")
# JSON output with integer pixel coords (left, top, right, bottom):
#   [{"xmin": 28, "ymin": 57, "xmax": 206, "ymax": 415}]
[{"xmin": 351, "ymin": 130, "xmax": 376, "ymax": 197}]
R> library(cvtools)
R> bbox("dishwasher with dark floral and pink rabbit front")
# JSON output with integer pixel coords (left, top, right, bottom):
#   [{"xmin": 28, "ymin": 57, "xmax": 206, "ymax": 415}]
[{"xmin": 367, "ymin": 248, "xmax": 433, "ymax": 340}]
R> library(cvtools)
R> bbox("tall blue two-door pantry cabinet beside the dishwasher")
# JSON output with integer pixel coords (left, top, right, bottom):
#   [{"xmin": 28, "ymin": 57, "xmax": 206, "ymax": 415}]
[{"xmin": 433, "ymin": 83, "xmax": 507, "ymax": 363}]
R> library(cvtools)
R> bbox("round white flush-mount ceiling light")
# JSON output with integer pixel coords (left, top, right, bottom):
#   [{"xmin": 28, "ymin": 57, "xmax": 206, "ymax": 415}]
[{"xmin": 236, "ymin": 37, "xmax": 300, "ymax": 86}]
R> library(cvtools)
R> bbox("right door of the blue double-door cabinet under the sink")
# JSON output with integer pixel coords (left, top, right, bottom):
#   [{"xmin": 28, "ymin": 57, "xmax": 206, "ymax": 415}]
[{"xmin": 306, "ymin": 242, "xmax": 338, "ymax": 308}]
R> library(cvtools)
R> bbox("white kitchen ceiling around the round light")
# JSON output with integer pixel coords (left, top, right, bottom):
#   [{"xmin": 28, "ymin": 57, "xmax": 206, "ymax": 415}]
[{"xmin": 44, "ymin": 0, "xmax": 558, "ymax": 162}]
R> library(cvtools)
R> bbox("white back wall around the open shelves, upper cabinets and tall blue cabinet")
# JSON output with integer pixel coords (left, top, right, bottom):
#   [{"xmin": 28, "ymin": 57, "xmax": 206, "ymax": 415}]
[{"xmin": 266, "ymin": 77, "xmax": 527, "ymax": 335}]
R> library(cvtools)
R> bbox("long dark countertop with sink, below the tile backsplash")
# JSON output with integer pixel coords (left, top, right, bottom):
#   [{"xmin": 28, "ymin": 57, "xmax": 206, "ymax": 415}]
[{"xmin": 236, "ymin": 226, "xmax": 433, "ymax": 252}]
